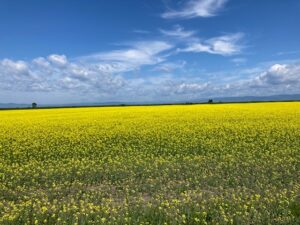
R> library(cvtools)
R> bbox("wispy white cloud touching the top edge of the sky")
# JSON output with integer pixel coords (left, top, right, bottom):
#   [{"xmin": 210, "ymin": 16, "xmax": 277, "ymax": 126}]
[{"xmin": 162, "ymin": 0, "xmax": 227, "ymax": 19}]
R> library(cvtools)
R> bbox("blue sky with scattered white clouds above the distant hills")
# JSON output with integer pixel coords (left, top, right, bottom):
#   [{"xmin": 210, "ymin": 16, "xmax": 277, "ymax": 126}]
[{"xmin": 0, "ymin": 0, "xmax": 300, "ymax": 103}]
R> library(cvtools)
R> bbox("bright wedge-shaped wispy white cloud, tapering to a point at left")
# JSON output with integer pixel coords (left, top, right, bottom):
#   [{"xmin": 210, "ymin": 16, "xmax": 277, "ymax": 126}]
[{"xmin": 178, "ymin": 33, "xmax": 244, "ymax": 56}]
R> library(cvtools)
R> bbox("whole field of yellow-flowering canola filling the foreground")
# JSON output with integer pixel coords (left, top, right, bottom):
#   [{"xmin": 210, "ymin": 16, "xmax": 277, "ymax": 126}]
[{"xmin": 0, "ymin": 102, "xmax": 300, "ymax": 225}]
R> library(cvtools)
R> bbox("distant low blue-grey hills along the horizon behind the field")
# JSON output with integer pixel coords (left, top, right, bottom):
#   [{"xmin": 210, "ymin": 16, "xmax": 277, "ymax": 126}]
[{"xmin": 0, "ymin": 94, "xmax": 300, "ymax": 109}]
